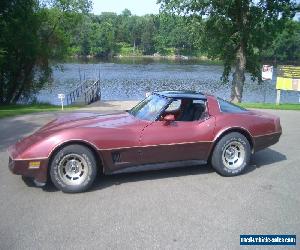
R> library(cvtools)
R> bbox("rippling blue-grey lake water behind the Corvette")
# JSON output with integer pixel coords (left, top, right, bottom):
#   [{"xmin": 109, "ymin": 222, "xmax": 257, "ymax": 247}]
[{"xmin": 37, "ymin": 58, "xmax": 299, "ymax": 104}]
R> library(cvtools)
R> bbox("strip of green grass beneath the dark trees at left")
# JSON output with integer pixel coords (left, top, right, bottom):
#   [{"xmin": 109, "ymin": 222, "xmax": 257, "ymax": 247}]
[{"xmin": 0, "ymin": 104, "xmax": 80, "ymax": 119}]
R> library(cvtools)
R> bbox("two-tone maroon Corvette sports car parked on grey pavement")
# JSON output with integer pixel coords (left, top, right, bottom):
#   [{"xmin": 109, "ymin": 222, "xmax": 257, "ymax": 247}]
[{"xmin": 9, "ymin": 91, "xmax": 281, "ymax": 192}]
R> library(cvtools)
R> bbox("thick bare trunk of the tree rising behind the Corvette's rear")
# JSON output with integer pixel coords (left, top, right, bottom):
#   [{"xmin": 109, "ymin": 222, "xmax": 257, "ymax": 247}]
[{"xmin": 231, "ymin": 43, "xmax": 246, "ymax": 103}]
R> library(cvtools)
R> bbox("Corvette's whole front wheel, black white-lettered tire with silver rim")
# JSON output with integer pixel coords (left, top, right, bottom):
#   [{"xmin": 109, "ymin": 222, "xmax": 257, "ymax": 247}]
[{"xmin": 50, "ymin": 144, "xmax": 98, "ymax": 193}]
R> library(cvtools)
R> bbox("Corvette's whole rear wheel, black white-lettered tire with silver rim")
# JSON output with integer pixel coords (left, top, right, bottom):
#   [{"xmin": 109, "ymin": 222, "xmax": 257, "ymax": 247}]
[{"xmin": 211, "ymin": 132, "xmax": 251, "ymax": 176}]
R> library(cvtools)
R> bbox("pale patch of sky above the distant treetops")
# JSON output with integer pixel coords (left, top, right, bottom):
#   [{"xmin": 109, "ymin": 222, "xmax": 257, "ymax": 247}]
[{"xmin": 93, "ymin": 0, "xmax": 159, "ymax": 16}]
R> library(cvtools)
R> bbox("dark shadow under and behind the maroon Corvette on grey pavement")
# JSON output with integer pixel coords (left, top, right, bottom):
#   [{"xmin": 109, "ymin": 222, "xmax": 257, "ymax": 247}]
[{"xmin": 43, "ymin": 148, "xmax": 287, "ymax": 192}]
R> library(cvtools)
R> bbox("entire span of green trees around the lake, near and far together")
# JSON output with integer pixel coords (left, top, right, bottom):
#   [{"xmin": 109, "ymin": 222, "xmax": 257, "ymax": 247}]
[{"xmin": 0, "ymin": 0, "xmax": 300, "ymax": 105}]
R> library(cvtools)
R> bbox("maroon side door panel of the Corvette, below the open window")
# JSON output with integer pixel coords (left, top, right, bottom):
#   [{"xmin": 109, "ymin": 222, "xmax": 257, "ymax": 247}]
[{"xmin": 140, "ymin": 117, "xmax": 215, "ymax": 164}]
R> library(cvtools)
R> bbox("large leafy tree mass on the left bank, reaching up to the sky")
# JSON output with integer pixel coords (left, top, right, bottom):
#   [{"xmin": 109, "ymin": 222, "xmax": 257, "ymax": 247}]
[{"xmin": 0, "ymin": 0, "xmax": 90, "ymax": 105}]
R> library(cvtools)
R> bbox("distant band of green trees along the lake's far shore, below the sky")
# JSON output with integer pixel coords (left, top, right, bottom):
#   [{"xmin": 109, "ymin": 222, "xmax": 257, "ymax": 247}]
[{"xmin": 67, "ymin": 10, "xmax": 202, "ymax": 56}]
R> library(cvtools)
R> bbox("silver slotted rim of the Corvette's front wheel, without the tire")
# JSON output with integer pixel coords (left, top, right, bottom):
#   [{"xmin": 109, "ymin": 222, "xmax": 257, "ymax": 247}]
[{"xmin": 58, "ymin": 154, "xmax": 89, "ymax": 185}]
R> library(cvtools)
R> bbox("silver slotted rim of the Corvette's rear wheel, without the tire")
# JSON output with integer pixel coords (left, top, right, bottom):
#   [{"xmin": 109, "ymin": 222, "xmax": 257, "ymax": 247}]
[{"xmin": 222, "ymin": 141, "xmax": 246, "ymax": 170}]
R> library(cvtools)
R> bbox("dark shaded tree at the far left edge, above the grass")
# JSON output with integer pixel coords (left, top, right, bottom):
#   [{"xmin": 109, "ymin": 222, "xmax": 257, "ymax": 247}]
[{"xmin": 0, "ymin": 0, "xmax": 47, "ymax": 104}]
